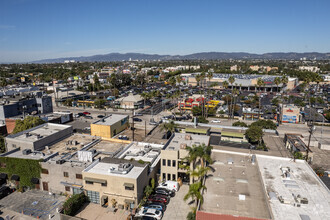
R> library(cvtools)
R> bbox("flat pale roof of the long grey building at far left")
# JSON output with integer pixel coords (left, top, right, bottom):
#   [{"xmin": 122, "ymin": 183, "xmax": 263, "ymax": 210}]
[{"xmin": 6, "ymin": 123, "xmax": 72, "ymax": 142}]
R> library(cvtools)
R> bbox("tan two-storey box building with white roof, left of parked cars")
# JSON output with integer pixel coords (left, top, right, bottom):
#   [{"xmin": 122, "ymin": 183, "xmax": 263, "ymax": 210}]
[{"xmin": 82, "ymin": 157, "xmax": 149, "ymax": 209}]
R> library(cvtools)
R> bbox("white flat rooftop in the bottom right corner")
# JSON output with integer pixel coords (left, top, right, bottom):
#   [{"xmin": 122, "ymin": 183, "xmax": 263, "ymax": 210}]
[{"xmin": 257, "ymin": 155, "xmax": 330, "ymax": 220}]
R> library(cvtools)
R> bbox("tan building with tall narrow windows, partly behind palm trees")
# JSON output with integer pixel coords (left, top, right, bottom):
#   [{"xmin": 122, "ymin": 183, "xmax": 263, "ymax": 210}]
[{"xmin": 160, "ymin": 133, "xmax": 210, "ymax": 183}]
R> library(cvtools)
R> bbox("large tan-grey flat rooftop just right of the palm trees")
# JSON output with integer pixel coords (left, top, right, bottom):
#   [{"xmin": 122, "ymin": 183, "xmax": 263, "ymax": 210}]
[{"xmin": 201, "ymin": 151, "xmax": 271, "ymax": 219}]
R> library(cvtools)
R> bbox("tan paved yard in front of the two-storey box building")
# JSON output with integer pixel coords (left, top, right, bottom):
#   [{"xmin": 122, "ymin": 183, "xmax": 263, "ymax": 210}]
[{"xmin": 76, "ymin": 203, "xmax": 130, "ymax": 220}]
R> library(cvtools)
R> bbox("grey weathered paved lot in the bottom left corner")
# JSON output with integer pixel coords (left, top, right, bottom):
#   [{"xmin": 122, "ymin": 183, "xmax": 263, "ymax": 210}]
[{"xmin": 0, "ymin": 190, "xmax": 65, "ymax": 219}]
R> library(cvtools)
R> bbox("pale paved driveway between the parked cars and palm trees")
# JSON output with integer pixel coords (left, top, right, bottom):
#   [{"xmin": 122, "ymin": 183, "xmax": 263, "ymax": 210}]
[{"xmin": 163, "ymin": 185, "xmax": 194, "ymax": 220}]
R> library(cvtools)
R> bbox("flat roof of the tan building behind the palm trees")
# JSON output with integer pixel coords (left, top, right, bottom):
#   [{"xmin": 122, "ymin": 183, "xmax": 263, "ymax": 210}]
[{"xmin": 166, "ymin": 133, "xmax": 210, "ymax": 150}]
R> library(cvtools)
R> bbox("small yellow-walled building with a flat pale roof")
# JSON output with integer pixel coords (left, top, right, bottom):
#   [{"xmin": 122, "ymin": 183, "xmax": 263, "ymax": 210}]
[{"xmin": 91, "ymin": 114, "xmax": 129, "ymax": 138}]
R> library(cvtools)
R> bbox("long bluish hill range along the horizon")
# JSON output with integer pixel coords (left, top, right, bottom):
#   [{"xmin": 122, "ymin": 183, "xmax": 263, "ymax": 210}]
[{"xmin": 32, "ymin": 52, "xmax": 330, "ymax": 63}]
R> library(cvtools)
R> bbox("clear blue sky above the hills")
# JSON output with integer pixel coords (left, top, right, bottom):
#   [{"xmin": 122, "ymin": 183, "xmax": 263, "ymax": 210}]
[{"xmin": 0, "ymin": 0, "xmax": 330, "ymax": 63}]
